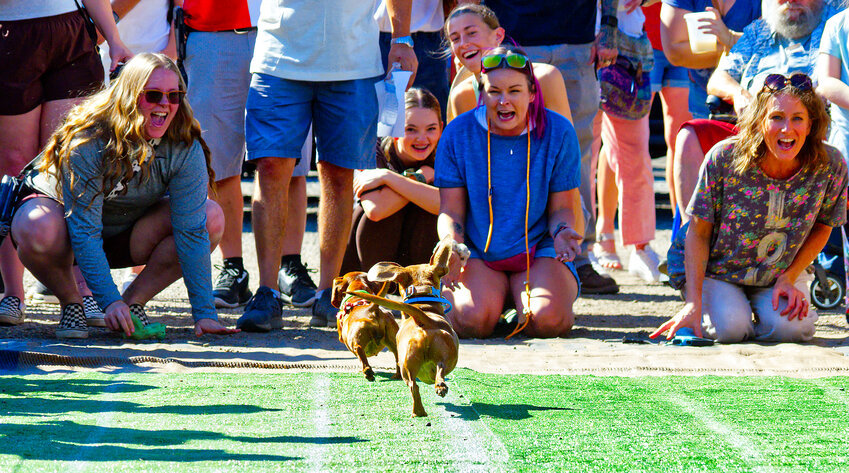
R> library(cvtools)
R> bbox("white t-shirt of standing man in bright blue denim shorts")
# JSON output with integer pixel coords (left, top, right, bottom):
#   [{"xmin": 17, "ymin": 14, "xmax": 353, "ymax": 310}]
[{"xmin": 251, "ymin": 0, "xmax": 383, "ymax": 81}]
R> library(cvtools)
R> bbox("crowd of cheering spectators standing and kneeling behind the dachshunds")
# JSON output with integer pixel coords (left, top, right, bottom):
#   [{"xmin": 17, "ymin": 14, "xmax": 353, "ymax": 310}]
[{"xmin": 0, "ymin": 0, "xmax": 849, "ymax": 342}]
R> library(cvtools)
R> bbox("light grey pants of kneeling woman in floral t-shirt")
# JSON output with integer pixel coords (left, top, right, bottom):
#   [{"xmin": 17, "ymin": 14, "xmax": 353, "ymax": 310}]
[{"xmin": 702, "ymin": 273, "xmax": 818, "ymax": 343}]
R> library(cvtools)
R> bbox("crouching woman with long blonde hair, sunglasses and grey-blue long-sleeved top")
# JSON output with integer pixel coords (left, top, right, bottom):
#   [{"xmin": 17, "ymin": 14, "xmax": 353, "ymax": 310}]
[{"xmin": 11, "ymin": 53, "xmax": 233, "ymax": 338}]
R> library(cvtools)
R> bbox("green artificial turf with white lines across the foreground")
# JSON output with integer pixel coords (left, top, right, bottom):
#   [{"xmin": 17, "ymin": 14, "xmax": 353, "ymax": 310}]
[{"xmin": 0, "ymin": 370, "xmax": 849, "ymax": 473}]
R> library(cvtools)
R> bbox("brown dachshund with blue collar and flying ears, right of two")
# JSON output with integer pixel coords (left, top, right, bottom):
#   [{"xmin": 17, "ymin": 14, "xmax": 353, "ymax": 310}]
[{"xmin": 349, "ymin": 243, "xmax": 460, "ymax": 417}]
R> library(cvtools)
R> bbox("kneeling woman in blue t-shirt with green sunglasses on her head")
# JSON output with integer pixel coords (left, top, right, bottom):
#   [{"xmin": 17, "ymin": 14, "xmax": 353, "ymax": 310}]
[{"xmin": 435, "ymin": 48, "xmax": 584, "ymax": 338}]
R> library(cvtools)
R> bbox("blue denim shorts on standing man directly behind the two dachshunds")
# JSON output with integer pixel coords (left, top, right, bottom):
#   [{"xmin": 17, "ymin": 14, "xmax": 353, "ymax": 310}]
[{"xmin": 245, "ymin": 73, "xmax": 381, "ymax": 169}]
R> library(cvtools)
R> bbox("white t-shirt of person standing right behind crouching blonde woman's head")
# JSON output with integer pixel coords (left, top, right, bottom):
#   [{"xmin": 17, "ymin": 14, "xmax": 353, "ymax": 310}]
[{"xmin": 100, "ymin": 0, "xmax": 171, "ymax": 84}]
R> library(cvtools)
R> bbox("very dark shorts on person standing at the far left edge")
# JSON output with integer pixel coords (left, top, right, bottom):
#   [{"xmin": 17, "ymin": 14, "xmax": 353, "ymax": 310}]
[{"xmin": 0, "ymin": 11, "xmax": 103, "ymax": 115}]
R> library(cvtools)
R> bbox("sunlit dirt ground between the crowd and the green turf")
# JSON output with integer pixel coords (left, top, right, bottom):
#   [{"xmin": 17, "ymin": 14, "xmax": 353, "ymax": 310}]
[{"xmin": 0, "ymin": 231, "xmax": 849, "ymax": 377}]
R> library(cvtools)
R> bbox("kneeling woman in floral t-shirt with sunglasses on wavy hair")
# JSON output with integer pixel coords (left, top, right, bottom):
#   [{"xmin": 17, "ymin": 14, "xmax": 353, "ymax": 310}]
[{"xmin": 651, "ymin": 74, "xmax": 847, "ymax": 343}]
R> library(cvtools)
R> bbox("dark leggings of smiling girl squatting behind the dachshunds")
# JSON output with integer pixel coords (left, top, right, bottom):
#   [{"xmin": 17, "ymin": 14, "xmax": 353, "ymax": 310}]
[{"xmin": 341, "ymin": 203, "xmax": 438, "ymax": 274}]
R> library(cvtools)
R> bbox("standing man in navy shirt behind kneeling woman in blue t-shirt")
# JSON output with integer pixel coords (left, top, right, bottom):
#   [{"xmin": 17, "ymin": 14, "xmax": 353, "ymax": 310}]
[{"xmin": 486, "ymin": 0, "xmax": 624, "ymax": 294}]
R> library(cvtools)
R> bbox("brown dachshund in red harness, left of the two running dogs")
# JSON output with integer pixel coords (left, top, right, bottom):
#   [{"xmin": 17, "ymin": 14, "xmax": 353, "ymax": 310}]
[{"xmin": 330, "ymin": 271, "xmax": 401, "ymax": 381}]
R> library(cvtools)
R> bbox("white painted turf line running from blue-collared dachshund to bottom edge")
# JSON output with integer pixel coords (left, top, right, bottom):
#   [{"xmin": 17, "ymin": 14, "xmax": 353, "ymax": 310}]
[{"xmin": 440, "ymin": 385, "xmax": 510, "ymax": 472}]
